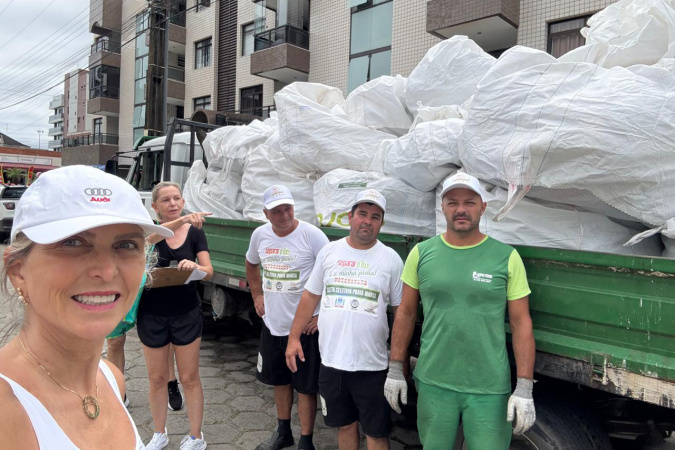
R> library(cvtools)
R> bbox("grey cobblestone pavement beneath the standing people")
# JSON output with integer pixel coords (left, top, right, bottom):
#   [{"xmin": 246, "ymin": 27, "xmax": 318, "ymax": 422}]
[{"xmin": 119, "ymin": 316, "xmax": 421, "ymax": 450}]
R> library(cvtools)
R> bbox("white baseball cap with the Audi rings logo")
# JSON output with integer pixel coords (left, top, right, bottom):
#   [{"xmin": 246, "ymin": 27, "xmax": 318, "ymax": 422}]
[{"xmin": 11, "ymin": 166, "xmax": 173, "ymax": 244}]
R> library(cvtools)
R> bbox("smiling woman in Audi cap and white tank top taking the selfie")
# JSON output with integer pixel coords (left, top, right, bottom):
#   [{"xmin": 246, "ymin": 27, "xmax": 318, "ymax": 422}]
[{"xmin": 0, "ymin": 166, "xmax": 173, "ymax": 450}]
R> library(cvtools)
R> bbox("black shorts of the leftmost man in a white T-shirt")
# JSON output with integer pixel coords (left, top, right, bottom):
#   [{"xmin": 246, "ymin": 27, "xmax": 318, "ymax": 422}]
[{"xmin": 256, "ymin": 322, "xmax": 321, "ymax": 394}]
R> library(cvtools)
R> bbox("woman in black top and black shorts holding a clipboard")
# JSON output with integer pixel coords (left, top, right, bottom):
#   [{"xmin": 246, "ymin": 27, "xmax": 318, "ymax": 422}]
[{"xmin": 137, "ymin": 182, "xmax": 213, "ymax": 450}]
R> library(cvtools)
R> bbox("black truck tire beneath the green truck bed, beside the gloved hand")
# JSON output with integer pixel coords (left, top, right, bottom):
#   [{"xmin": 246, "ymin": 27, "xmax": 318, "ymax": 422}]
[{"xmin": 454, "ymin": 394, "xmax": 612, "ymax": 450}]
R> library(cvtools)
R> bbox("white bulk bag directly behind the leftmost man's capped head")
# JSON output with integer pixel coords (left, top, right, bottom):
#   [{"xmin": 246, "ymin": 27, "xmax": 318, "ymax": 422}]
[{"xmin": 241, "ymin": 141, "xmax": 318, "ymax": 224}]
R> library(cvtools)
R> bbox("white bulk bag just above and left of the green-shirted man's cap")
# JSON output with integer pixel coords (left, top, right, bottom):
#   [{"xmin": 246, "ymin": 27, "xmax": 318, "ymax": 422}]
[{"xmin": 384, "ymin": 119, "xmax": 464, "ymax": 192}]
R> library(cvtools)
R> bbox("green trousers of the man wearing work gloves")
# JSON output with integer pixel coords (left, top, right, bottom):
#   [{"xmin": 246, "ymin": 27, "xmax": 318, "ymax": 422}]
[{"xmin": 415, "ymin": 381, "xmax": 511, "ymax": 450}]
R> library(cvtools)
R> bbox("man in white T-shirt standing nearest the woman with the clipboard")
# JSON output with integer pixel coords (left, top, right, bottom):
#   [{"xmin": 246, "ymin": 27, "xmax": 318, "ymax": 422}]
[{"xmin": 246, "ymin": 185, "xmax": 328, "ymax": 450}]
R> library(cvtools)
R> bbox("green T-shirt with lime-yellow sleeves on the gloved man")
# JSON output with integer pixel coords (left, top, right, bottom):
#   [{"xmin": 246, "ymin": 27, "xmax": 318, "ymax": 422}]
[{"xmin": 401, "ymin": 235, "xmax": 530, "ymax": 394}]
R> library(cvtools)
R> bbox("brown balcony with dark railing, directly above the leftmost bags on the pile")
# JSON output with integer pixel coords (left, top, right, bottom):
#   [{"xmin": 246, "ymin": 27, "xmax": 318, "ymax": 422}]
[{"xmin": 251, "ymin": 25, "xmax": 309, "ymax": 84}]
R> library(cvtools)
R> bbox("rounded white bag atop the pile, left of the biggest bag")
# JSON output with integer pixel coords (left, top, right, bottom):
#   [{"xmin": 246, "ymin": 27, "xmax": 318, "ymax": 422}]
[{"xmin": 405, "ymin": 36, "xmax": 495, "ymax": 116}]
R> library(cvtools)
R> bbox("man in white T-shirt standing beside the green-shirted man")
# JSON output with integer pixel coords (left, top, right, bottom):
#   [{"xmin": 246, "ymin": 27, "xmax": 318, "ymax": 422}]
[{"xmin": 286, "ymin": 189, "xmax": 403, "ymax": 450}]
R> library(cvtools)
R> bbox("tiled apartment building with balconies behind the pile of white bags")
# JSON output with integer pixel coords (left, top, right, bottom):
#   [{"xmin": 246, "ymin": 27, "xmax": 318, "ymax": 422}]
[{"xmin": 76, "ymin": 0, "xmax": 613, "ymax": 163}]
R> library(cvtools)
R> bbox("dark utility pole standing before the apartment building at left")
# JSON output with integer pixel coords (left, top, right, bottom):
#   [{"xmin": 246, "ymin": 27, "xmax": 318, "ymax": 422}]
[{"xmin": 145, "ymin": 0, "xmax": 170, "ymax": 136}]
